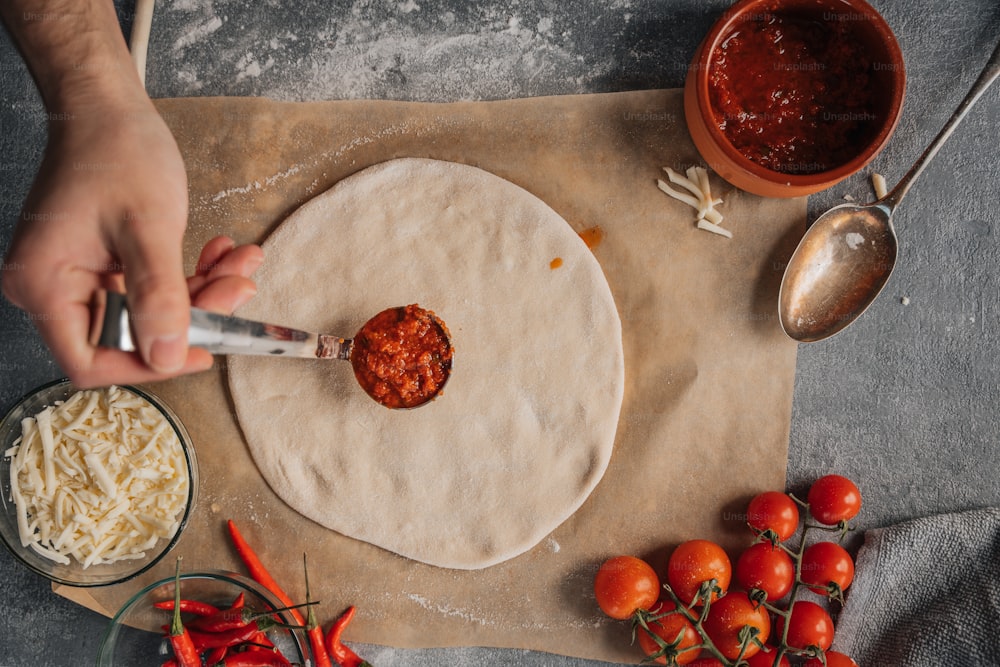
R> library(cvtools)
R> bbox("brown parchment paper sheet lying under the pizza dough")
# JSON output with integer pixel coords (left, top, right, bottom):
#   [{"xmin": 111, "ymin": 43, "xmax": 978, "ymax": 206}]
[{"xmin": 56, "ymin": 90, "xmax": 805, "ymax": 662}]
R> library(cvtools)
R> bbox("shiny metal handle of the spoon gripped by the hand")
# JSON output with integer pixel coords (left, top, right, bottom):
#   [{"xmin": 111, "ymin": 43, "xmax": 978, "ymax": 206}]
[{"xmin": 96, "ymin": 292, "xmax": 351, "ymax": 359}]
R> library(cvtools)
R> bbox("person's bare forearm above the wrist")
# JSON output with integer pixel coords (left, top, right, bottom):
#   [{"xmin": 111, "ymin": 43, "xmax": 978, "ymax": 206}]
[{"xmin": 0, "ymin": 0, "xmax": 142, "ymax": 113}]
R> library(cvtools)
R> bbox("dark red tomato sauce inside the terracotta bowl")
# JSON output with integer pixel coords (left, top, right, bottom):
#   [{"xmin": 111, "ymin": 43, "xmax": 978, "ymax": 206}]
[{"xmin": 709, "ymin": 13, "xmax": 880, "ymax": 174}]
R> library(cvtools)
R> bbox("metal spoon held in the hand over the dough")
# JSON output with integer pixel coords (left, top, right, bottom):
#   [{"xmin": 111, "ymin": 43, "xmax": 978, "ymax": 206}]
[{"xmin": 91, "ymin": 291, "xmax": 453, "ymax": 408}]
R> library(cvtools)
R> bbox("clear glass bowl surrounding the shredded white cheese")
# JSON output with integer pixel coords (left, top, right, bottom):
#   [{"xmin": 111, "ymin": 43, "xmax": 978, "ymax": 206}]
[{"xmin": 0, "ymin": 379, "xmax": 198, "ymax": 587}]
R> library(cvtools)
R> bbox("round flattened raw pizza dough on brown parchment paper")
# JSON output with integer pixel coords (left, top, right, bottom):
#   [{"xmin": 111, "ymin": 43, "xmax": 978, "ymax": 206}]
[{"xmin": 229, "ymin": 159, "xmax": 624, "ymax": 569}]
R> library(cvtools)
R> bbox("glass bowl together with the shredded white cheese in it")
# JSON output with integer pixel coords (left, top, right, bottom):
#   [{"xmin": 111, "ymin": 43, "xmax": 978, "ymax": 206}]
[{"xmin": 0, "ymin": 380, "xmax": 198, "ymax": 586}]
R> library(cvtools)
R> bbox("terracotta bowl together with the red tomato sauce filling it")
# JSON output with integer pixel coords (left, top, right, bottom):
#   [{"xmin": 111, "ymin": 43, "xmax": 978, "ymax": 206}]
[{"xmin": 684, "ymin": 0, "xmax": 906, "ymax": 197}]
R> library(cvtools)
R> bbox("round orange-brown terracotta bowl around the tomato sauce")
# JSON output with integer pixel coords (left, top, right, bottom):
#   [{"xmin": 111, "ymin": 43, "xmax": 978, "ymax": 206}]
[{"xmin": 684, "ymin": 0, "xmax": 906, "ymax": 197}]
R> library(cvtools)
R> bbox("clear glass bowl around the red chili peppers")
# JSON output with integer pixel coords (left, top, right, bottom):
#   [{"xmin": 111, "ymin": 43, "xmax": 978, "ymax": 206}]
[{"xmin": 96, "ymin": 570, "xmax": 307, "ymax": 667}]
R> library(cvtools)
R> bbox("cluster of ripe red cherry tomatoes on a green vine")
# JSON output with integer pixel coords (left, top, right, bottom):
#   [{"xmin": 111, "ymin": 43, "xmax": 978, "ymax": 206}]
[{"xmin": 594, "ymin": 475, "xmax": 861, "ymax": 667}]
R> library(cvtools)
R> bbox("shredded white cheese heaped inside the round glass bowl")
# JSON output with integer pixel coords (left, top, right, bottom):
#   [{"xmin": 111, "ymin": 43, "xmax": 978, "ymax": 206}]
[{"xmin": 3, "ymin": 387, "xmax": 190, "ymax": 568}]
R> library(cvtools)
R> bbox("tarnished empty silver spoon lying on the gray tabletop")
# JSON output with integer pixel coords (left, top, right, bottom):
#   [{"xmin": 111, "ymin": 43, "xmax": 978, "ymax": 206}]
[{"xmin": 778, "ymin": 38, "xmax": 1000, "ymax": 343}]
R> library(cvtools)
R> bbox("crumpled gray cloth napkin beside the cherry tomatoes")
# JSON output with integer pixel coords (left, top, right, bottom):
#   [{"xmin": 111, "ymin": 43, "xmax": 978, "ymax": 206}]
[{"xmin": 833, "ymin": 507, "xmax": 1000, "ymax": 667}]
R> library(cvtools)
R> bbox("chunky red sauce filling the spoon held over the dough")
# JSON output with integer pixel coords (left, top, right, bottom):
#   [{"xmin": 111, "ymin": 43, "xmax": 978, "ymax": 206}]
[{"xmin": 351, "ymin": 304, "xmax": 454, "ymax": 408}]
